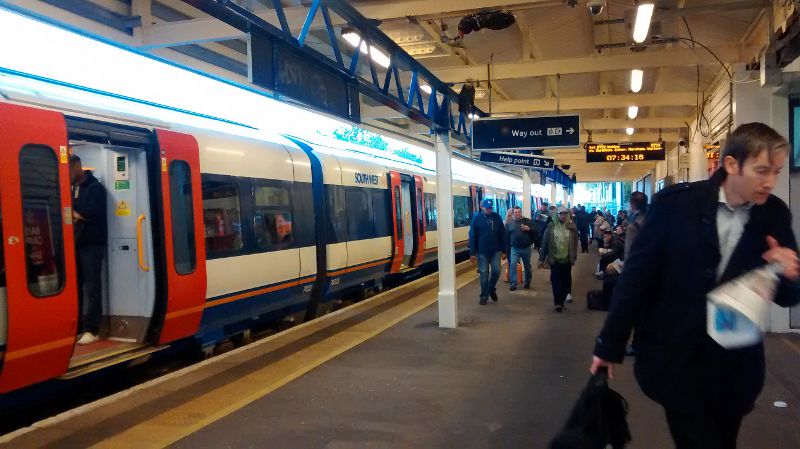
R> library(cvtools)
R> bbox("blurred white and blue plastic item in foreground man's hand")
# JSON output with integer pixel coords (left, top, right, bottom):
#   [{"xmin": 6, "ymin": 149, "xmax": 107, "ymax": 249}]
[{"xmin": 706, "ymin": 263, "xmax": 783, "ymax": 349}]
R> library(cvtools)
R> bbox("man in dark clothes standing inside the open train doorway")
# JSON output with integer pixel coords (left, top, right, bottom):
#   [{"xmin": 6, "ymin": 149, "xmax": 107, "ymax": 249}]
[{"xmin": 69, "ymin": 154, "xmax": 108, "ymax": 345}]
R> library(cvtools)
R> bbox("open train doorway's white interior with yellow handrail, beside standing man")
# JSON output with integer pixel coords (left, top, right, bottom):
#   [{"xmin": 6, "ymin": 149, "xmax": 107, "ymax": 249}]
[{"xmin": 71, "ymin": 143, "xmax": 156, "ymax": 356}]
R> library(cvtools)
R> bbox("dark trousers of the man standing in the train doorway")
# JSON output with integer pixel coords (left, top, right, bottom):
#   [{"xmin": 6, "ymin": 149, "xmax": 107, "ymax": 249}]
[{"xmin": 75, "ymin": 245, "xmax": 106, "ymax": 335}]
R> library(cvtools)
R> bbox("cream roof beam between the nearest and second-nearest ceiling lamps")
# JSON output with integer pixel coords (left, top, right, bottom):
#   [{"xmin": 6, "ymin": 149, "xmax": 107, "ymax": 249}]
[{"xmin": 433, "ymin": 46, "xmax": 745, "ymax": 83}]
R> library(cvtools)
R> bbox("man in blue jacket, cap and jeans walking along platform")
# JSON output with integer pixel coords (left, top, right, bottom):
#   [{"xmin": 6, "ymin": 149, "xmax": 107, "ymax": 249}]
[{"xmin": 469, "ymin": 199, "xmax": 507, "ymax": 305}]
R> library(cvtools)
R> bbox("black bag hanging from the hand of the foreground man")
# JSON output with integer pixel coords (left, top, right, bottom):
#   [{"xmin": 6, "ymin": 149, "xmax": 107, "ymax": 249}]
[{"xmin": 549, "ymin": 368, "xmax": 631, "ymax": 449}]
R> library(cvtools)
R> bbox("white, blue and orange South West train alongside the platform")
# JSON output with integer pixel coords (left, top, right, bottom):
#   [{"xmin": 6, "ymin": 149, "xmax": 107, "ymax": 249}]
[{"xmin": 0, "ymin": 93, "xmax": 556, "ymax": 394}]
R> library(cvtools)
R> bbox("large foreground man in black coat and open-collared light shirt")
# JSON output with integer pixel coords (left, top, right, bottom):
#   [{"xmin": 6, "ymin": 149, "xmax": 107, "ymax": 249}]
[{"xmin": 591, "ymin": 123, "xmax": 800, "ymax": 449}]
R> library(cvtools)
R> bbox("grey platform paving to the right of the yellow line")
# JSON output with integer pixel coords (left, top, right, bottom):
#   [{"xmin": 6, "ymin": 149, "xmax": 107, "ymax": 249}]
[{"xmin": 171, "ymin": 254, "xmax": 800, "ymax": 449}]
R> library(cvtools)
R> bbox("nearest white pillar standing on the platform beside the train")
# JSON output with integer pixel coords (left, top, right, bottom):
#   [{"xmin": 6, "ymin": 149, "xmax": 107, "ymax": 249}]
[{"xmin": 434, "ymin": 133, "xmax": 458, "ymax": 329}]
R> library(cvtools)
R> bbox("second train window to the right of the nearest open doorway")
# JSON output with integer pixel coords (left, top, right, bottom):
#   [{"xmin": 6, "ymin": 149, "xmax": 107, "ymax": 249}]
[{"xmin": 253, "ymin": 185, "xmax": 294, "ymax": 251}]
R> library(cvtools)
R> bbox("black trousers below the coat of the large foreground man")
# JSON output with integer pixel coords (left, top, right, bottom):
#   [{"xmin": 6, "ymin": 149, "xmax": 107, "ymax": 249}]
[{"xmin": 665, "ymin": 410, "xmax": 743, "ymax": 449}]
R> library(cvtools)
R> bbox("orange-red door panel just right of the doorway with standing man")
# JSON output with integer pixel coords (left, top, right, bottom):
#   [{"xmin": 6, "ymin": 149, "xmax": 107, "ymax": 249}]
[{"xmin": 154, "ymin": 129, "xmax": 206, "ymax": 344}]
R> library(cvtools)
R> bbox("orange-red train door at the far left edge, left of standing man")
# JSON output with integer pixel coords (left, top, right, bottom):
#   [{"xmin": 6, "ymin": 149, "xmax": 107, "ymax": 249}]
[{"xmin": 0, "ymin": 104, "xmax": 78, "ymax": 393}]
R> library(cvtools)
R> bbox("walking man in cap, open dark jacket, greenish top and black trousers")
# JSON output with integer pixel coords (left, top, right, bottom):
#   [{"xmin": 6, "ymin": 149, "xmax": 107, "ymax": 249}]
[{"xmin": 539, "ymin": 206, "xmax": 578, "ymax": 312}]
